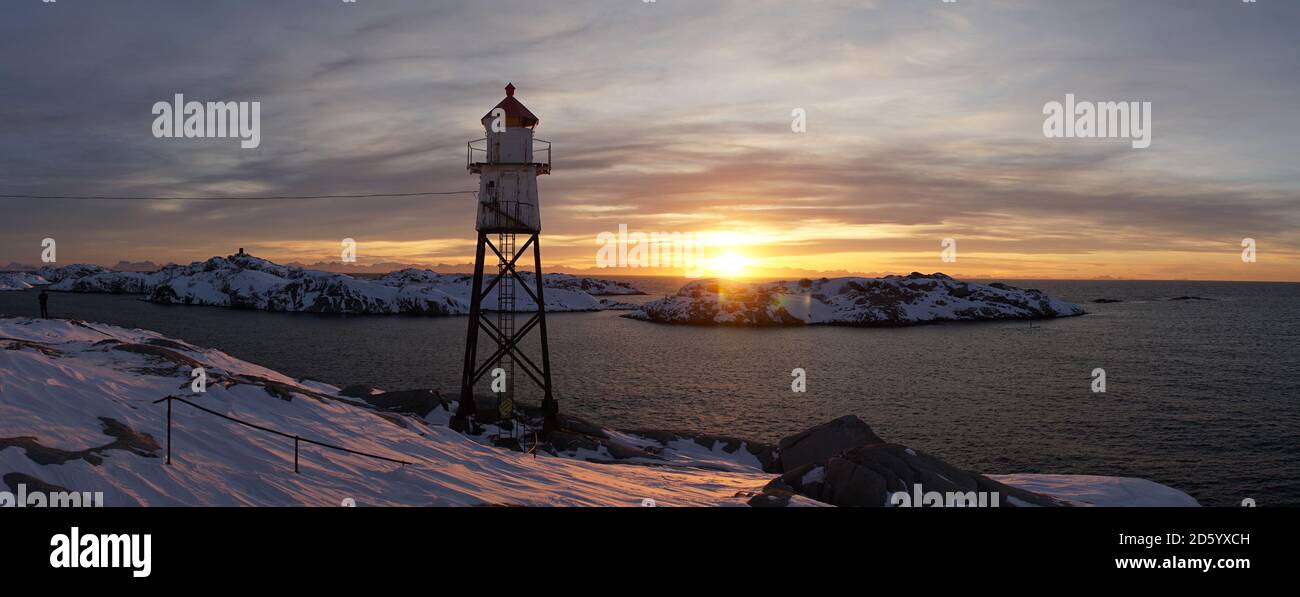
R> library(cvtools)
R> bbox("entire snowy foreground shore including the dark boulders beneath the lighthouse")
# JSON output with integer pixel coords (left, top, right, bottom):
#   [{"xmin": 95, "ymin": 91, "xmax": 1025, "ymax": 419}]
[{"xmin": 0, "ymin": 317, "xmax": 1195, "ymax": 506}]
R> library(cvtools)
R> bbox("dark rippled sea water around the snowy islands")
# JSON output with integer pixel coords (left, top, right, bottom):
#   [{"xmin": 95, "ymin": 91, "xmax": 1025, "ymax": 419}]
[{"xmin": 0, "ymin": 278, "xmax": 1300, "ymax": 506}]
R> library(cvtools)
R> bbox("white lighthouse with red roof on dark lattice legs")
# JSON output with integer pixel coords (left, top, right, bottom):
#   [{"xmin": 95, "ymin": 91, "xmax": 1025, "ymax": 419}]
[{"xmin": 451, "ymin": 85, "xmax": 559, "ymax": 446}]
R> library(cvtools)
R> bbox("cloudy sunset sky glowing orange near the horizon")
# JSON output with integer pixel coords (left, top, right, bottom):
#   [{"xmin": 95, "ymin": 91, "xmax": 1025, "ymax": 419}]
[{"xmin": 0, "ymin": 0, "xmax": 1300, "ymax": 281}]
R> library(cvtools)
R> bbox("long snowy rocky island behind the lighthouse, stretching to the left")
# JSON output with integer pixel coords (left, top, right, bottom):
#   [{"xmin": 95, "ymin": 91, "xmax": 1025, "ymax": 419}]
[{"xmin": 43, "ymin": 254, "xmax": 636, "ymax": 315}]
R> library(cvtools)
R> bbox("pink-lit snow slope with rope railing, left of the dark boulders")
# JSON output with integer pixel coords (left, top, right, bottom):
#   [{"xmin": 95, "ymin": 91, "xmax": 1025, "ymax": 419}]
[{"xmin": 0, "ymin": 319, "xmax": 771, "ymax": 506}]
